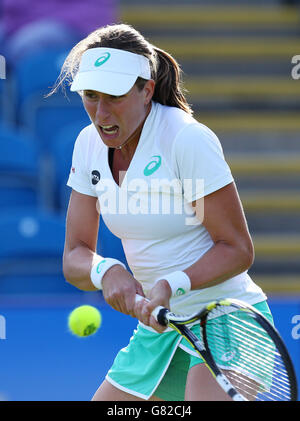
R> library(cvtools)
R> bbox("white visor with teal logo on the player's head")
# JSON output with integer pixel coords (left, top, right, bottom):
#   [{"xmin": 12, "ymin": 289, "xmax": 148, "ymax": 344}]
[{"xmin": 71, "ymin": 47, "xmax": 151, "ymax": 95}]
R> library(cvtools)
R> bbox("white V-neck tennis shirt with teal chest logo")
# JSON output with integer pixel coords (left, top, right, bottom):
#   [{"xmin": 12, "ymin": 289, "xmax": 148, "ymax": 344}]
[{"xmin": 67, "ymin": 102, "xmax": 266, "ymax": 313}]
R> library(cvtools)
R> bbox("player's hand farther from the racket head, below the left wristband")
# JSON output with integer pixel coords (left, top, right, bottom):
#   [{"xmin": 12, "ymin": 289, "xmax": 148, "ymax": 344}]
[{"xmin": 102, "ymin": 265, "xmax": 145, "ymax": 317}]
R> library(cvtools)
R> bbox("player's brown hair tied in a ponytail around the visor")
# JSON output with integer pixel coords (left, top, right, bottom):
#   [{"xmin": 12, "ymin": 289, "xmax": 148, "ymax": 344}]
[{"xmin": 49, "ymin": 24, "xmax": 192, "ymax": 114}]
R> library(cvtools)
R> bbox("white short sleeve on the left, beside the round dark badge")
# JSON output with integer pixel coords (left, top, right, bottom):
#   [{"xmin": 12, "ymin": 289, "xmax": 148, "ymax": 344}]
[{"xmin": 67, "ymin": 126, "xmax": 97, "ymax": 197}]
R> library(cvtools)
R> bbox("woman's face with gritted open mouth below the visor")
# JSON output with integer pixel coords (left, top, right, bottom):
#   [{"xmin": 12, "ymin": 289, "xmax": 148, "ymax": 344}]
[{"xmin": 82, "ymin": 80, "xmax": 154, "ymax": 148}]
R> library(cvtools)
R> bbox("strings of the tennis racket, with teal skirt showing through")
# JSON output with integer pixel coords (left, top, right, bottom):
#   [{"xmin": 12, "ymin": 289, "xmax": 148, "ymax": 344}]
[{"xmin": 206, "ymin": 306, "xmax": 291, "ymax": 401}]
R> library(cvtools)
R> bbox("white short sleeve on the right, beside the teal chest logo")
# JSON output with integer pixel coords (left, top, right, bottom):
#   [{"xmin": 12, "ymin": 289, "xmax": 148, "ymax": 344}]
[{"xmin": 173, "ymin": 123, "xmax": 233, "ymax": 203}]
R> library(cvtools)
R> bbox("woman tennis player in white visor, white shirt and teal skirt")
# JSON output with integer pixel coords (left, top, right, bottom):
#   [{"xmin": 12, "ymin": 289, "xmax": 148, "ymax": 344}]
[{"xmin": 57, "ymin": 24, "xmax": 271, "ymax": 401}]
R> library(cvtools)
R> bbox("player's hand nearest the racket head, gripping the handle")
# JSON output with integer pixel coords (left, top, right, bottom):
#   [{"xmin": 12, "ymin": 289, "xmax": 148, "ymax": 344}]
[{"xmin": 134, "ymin": 279, "xmax": 171, "ymax": 333}]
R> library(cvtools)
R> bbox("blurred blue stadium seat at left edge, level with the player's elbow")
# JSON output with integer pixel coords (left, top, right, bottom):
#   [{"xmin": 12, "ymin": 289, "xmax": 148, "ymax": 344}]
[{"xmin": 0, "ymin": 207, "xmax": 78, "ymax": 294}]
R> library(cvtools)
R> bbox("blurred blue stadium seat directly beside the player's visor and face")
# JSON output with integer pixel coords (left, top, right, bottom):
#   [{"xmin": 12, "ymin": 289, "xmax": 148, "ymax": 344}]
[{"xmin": 12, "ymin": 47, "xmax": 89, "ymax": 152}]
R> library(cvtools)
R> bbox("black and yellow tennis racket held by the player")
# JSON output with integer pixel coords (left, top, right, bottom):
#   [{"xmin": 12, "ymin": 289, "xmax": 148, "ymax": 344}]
[{"xmin": 136, "ymin": 296, "xmax": 297, "ymax": 401}]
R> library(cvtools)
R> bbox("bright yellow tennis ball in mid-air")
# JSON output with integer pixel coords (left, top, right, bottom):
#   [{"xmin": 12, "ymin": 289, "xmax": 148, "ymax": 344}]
[{"xmin": 68, "ymin": 305, "xmax": 102, "ymax": 337}]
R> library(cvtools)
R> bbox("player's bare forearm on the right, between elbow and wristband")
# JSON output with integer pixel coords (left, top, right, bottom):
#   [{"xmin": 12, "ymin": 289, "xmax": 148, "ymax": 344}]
[{"xmin": 184, "ymin": 241, "xmax": 254, "ymax": 289}]
